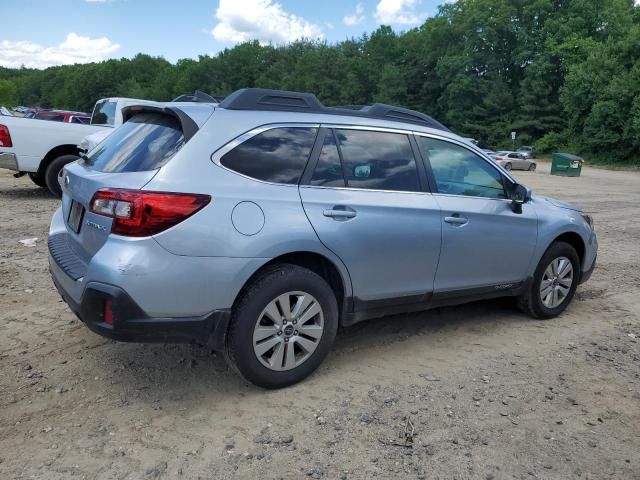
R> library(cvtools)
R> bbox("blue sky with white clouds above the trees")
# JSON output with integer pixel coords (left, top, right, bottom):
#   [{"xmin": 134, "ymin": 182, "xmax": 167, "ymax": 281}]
[{"xmin": 0, "ymin": 0, "xmax": 446, "ymax": 68}]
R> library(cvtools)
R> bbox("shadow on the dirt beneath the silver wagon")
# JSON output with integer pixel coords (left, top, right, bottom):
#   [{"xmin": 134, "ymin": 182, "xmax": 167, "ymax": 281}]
[{"xmin": 90, "ymin": 298, "xmax": 531, "ymax": 398}]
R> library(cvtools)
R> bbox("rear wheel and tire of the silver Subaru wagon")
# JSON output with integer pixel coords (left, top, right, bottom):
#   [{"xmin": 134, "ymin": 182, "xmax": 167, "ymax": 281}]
[{"xmin": 225, "ymin": 264, "xmax": 338, "ymax": 388}]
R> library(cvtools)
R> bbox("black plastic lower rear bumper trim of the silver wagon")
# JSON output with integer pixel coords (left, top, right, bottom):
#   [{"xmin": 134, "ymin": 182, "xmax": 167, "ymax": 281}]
[{"xmin": 54, "ymin": 278, "xmax": 231, "ymax": 350}]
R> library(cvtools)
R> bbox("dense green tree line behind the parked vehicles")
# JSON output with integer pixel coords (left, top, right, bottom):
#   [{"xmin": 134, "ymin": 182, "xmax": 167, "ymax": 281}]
[{"xmin": 0, "ymin": 0, "xmax": 640, "ymax": 164}]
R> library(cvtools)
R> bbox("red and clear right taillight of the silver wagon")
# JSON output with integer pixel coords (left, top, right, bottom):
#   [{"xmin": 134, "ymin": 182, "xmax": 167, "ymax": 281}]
[{"xmin": 89, "ymin": 188, "xmax": 211, "ymax": 237}]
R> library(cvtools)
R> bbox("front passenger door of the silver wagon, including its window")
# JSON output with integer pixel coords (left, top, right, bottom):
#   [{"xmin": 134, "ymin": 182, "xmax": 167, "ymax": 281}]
[{"xmin": 416, "ymin": 136, "xmax": 538, "ymax": 294}]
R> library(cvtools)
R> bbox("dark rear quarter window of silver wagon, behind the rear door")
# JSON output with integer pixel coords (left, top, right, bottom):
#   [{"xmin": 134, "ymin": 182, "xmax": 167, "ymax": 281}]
[{"xmin": 220, "ymin": 127, "xmax": 318, "ymax": 185}]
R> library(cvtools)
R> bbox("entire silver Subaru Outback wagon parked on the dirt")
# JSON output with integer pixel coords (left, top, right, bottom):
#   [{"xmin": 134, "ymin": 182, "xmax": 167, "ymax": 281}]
[{"xmin": 48, "ymin": 89, "xmax": 598, "ymax": 388}]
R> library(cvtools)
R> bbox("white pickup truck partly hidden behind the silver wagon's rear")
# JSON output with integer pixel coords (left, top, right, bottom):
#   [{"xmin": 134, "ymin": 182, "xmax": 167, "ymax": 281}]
[{"xmin": 0, "ymin": 98, "xmax": 160, "ymax": 197}]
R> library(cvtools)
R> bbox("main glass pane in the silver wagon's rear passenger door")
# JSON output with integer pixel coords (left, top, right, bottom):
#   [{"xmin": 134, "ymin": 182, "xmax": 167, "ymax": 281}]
[{"xmin": 335, "ymin": 129, "xmax": 421, "ymax": 192}]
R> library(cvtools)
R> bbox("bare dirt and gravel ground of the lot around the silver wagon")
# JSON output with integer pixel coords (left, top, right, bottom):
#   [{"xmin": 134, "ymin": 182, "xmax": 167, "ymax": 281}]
[{"xmin": 0, "ymin": 164, "xmax": 640, "ymax": 480}]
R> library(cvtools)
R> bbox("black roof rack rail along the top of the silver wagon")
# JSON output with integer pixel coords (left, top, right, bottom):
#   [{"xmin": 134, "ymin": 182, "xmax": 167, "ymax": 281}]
[{"xmin": 219, "ymin": 88, "xmax": 450, "ymax": 132}]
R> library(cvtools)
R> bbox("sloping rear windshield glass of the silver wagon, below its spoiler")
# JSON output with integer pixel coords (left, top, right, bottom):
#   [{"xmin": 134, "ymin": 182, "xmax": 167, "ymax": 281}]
[{"xmin": 84, "ymin": 113, "xmax": 184, "ymax": 173}]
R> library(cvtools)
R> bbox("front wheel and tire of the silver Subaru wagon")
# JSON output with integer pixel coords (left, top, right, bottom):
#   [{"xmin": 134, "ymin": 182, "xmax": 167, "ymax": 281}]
[{"xmin": 518, "ymin": 242, "xmax": 581, "ymax": 320}]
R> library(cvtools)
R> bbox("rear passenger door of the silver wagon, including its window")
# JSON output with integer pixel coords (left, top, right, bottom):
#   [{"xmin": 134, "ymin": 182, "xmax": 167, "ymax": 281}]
[{"xmin": 300, "ymin": 127, "xmax": 441, "ymax": 310}]
